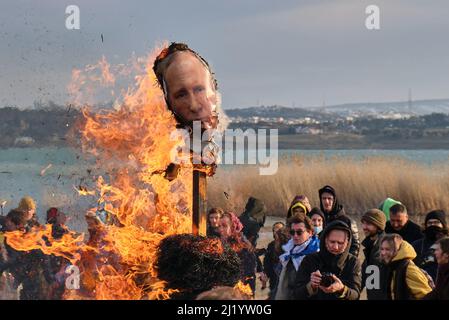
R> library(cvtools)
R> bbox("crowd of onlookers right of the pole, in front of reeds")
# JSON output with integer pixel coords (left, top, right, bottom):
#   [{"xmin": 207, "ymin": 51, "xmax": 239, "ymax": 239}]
[{"xmin": 204, "ymin": 186, "xmax": 449, "ymax": 300}]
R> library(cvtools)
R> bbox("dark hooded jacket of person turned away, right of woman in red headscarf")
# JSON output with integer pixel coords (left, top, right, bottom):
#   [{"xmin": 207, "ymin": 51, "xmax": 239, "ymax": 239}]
[{"xmin": 239, "ymin": 197, "xmax": 267, "ymax": 247}]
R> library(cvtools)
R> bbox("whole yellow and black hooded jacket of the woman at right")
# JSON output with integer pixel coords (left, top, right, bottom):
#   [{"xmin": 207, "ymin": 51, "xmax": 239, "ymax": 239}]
[{"xmin": 387, "ymin": 241, "xmax": 432, "ymax": 300}]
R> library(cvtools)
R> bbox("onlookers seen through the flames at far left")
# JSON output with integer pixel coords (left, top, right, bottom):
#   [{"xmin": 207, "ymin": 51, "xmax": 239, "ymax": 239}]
[{"xmin": 0, "ymin": 196, "xmax": 120, "ymax": 300}]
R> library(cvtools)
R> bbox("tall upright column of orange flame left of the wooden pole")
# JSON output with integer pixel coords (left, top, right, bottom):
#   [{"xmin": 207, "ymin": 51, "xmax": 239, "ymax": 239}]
[{"xmin": 74, "ymin": 43, "xmax": 196, "ymax": 299}]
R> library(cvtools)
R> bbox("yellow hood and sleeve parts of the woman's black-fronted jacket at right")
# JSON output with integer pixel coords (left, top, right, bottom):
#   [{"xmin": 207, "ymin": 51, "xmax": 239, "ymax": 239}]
[{"xmin": 390, "ymin": 240, "xmax": 432, "ymax": 300}]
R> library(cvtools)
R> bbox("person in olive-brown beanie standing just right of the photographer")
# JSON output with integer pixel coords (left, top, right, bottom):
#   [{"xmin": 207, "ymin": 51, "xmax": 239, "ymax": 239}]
[{"xmin": 362, "ymin": 209, "xmax": 387, "ymax": 300}]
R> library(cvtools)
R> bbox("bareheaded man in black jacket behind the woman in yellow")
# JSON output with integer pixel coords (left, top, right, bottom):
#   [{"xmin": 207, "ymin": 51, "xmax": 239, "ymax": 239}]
[{"xmin": 385, "ymin": 204, "xmax": 423, "ymax": 243}]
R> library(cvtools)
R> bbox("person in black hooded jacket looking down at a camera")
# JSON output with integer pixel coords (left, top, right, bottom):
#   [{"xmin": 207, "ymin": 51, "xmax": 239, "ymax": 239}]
[{"xmin": 294, "ymin": 220, "xmax": 362, "ymax": 300}]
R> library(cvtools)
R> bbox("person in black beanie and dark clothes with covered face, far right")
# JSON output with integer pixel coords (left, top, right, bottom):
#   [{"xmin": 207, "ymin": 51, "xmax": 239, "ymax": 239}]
[{"xmin": 412, "ymin": 210, "xmax": 448, "ymax": 281}]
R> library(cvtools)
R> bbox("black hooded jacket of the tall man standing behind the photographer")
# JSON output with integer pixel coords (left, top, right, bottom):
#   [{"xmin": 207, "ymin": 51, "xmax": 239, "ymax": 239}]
[{"xmin": 318, "ymin": 186, "xmax": 360, "ymax": 257}]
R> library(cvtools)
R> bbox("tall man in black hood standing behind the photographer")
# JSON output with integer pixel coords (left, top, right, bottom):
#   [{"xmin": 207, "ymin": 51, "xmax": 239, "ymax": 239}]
[{"xmin": 318, "ymin": 186, "xmax": 360, "ymax": 257}]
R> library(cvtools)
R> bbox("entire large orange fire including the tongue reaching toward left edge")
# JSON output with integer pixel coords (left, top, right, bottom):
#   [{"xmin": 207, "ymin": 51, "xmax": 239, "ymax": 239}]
[{"xmin": 7, "ymin": 45, "xmax": 198, "ymax": 299}]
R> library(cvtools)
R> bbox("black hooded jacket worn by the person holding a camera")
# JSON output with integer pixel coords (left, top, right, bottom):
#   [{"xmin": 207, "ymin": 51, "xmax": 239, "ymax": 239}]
[{"xmin": 294, "ymin": 220, "xmax": 362, "ymax": 300}]
